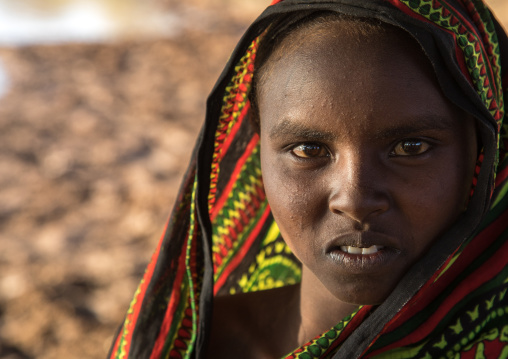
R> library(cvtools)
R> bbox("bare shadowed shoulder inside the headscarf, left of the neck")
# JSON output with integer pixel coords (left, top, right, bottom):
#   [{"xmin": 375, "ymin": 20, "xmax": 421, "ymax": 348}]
[{"xmin": 208, "ymin": 286, "xmax": 298, "ymax": 359}]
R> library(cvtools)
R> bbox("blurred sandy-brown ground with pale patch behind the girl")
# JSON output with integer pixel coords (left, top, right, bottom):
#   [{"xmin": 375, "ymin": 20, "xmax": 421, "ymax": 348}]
[{"xmin": 0, "ymin": 0, "xmax": 508, "ymax": 359}]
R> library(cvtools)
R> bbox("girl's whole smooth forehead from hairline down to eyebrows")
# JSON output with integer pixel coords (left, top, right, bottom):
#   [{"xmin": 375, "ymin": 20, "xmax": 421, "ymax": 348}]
[{"xmin": 257, "ymin": 21, "xmax": 457, "ymax": 136}]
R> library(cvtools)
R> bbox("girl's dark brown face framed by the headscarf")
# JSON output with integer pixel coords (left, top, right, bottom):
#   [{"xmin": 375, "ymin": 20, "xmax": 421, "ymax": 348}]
[{"xmin": 258, "ymin": 26, "xmax": 477, "ymax": 304}]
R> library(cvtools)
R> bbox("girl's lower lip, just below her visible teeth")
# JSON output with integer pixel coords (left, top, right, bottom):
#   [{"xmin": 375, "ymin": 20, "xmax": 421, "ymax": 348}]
[{"xmin": 326, "ymin": 247, "xmax": 400, "ymax": 274}]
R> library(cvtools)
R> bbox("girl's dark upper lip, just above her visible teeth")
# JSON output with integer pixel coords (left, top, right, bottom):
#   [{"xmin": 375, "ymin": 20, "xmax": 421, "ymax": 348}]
[{"xmin": 326, "ymin": 231, "xmax": 398, "ymax": 253}]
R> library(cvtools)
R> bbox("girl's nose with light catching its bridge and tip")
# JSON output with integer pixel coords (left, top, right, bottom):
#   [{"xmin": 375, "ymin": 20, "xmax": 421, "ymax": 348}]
[{"xmin": 329, "ymin": 153, "xmax": 392, "ymax": 224}]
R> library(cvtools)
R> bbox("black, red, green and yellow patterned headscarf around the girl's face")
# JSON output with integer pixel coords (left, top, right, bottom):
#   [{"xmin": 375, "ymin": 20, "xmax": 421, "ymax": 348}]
[{"xmin": 109, "ymin": 0, "xmax": 508, "ymax": 359}]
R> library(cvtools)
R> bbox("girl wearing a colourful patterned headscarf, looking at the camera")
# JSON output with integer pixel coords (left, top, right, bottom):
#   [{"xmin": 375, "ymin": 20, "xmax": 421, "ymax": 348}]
[{"xmin": 110, "ymin": 0, "xmax": 508, "ymax": 358}]
